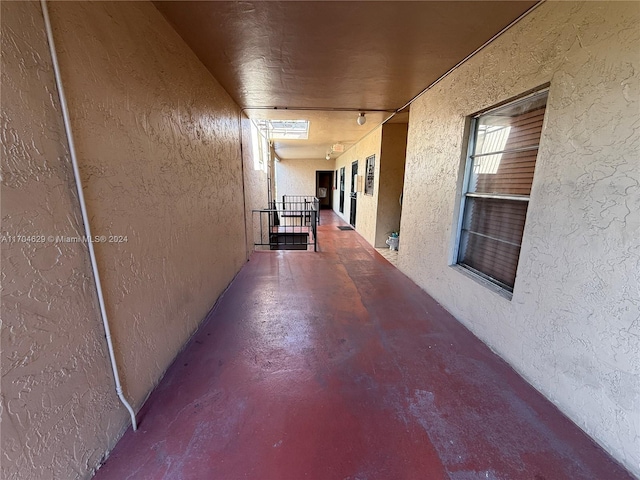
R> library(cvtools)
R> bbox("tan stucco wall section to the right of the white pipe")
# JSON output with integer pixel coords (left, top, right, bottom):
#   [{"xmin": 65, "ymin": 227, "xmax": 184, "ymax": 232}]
[{"xmin": 51, "ymin": 2, "xmax": 246, "ymax": 405}]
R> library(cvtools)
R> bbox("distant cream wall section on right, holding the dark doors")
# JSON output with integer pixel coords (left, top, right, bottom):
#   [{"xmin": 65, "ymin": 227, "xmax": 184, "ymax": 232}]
[{"xmin": 333, "ymin": 127, "xmax": 382, "ymax": 245}]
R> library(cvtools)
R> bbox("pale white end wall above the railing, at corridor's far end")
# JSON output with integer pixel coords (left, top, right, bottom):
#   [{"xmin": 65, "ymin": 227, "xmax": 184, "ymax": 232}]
[{"xmin": 274, "ymin": 158, "xmax": 334, "ymax": 201}]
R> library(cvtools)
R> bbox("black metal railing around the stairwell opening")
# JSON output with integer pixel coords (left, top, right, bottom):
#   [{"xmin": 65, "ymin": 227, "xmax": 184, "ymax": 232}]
[{"xmin": 252, "ymin": 195, "xmax": 320, "ymax": 252}]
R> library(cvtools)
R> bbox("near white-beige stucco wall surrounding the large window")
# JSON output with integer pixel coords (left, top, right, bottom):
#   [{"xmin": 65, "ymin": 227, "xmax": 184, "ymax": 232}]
[{"xmin": 399, "ymin": 2, "xmax": 640, "ymax": 475}]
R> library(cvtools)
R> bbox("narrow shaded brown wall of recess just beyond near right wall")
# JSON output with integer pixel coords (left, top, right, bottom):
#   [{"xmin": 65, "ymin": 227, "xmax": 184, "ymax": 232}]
[{"xmin": 374, "ymin": 123, "xmax": 408, "ymax": 247}]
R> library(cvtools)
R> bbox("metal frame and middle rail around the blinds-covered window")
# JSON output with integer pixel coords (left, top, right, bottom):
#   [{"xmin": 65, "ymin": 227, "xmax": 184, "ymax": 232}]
[{"xmin": 451, "ymin": 84, "xmax": 549, "ymax": 300}]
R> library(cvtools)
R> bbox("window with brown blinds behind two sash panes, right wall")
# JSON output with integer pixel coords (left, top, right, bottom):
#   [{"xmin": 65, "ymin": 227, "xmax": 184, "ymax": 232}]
[{"xmin": 458, "ymin": 91, "xmax": 547, "ymax": 292}]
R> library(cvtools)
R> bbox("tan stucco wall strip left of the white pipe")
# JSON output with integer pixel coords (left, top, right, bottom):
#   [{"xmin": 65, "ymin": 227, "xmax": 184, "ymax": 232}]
[{"xmin": 0, "ymin": 2, "xmax": 126, "ymax": 480}]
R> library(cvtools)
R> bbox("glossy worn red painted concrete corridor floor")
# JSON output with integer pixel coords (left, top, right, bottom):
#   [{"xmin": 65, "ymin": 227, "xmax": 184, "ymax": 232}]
[{"xmin": 95, "ymin": 212, "xmax": 632, "ymax": 480}]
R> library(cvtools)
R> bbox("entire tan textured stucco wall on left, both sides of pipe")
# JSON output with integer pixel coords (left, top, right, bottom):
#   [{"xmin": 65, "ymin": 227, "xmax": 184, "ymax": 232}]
[{"xmin": 1, "ymin": 2, "xmax": 246, "ymax": 479}]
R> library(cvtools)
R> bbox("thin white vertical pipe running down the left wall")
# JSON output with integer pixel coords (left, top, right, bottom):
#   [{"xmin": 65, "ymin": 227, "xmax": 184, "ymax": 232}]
[{"xmin": 40, "ymin": 0, "xmax": 138, "ymax": 431}]
